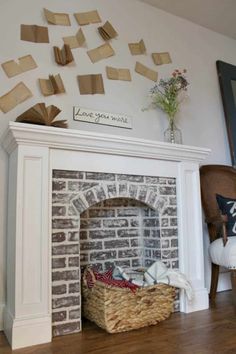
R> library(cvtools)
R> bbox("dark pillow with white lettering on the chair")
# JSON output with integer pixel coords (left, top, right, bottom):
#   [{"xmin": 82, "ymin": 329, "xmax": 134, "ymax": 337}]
[{"xmin": 216, "ymin": 194, "xmax": 236, "ymax": 237}]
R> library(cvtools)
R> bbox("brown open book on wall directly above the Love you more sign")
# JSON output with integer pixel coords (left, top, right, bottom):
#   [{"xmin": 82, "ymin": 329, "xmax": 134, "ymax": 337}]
[{"xmin": 77, "ymin": 74, "xmax": 105, "ymax": 95}]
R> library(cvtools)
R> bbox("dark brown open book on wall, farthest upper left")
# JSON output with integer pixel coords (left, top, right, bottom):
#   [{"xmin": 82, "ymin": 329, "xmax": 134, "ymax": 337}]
[{"xmin": 20, "ymin": 25, "xmax": 49, "ymax": 43}]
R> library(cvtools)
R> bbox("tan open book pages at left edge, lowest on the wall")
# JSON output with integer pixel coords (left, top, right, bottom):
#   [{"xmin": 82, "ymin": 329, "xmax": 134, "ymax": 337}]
[{"xmin": 0, "ymin": 82, "xmax": 33, "ymax": 113}]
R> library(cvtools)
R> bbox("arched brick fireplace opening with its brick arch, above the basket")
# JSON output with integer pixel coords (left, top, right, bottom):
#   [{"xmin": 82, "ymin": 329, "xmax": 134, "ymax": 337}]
[{"xmin": 71, "ymin": 182, "xmax": 170, "ymax": 271}]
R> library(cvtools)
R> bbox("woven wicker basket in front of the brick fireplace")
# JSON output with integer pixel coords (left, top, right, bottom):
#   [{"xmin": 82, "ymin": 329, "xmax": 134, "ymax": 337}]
[{"xmin": 82, "ymin": 270, "xmax": 175, "ymax": 333}]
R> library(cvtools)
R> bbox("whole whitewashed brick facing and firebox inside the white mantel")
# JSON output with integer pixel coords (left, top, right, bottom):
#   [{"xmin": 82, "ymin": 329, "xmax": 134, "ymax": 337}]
[{"xmin": 52, "ymin": 170, "xmax": 179, "ymax": 336}]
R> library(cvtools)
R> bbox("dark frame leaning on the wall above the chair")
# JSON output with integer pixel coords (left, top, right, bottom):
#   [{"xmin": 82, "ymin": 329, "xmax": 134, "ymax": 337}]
[{"xmin": 216, "ymin": 60, "xmax": 236, "ymax": 167}]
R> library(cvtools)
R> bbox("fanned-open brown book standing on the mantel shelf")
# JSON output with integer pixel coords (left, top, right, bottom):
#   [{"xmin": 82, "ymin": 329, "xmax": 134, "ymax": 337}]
[{"xmin": 16, "ymin": 102, "xmax": 67, "ymax": 128}]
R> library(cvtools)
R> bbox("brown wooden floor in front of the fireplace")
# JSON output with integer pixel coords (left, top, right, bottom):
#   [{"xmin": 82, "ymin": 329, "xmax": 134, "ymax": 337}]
[{"xmin": 0, "ymin": 291, "xmax": 236, "ymax": 354}]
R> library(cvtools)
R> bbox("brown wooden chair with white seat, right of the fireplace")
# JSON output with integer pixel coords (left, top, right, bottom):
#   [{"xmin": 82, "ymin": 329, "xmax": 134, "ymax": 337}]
[{"xmin": 200, "ymin": 165, "xmax": 236, "ymax": 305}]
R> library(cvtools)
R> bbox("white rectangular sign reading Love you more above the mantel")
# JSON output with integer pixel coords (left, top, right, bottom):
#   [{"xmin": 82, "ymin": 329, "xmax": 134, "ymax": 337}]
[{"xmin": 73, "ymin": 107, "xmax": 132, "ymax": 129}]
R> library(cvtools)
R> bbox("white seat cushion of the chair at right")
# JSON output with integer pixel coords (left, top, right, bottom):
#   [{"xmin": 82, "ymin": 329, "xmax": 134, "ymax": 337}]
[{"xmin": 209, "ymin": 236, "xmax": 236, "ymax": 269}]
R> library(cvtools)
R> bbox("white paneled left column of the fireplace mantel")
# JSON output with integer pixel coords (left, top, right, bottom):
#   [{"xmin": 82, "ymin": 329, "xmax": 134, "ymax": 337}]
[{"xmin": 4, "ymin": 145, "xmax": 51, "ymax": 349}]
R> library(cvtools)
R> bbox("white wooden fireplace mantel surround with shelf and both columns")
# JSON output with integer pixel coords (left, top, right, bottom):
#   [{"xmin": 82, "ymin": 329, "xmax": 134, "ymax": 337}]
[{"xmin": 2, "ymin": 122, "xmax": 210, "ymax": 349}]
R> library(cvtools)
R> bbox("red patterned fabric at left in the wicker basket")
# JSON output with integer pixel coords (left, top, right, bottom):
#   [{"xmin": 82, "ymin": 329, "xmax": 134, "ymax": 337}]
[{"xmin": 85, "ymin": 268, "xmax": 139, "ymax": 292}]
